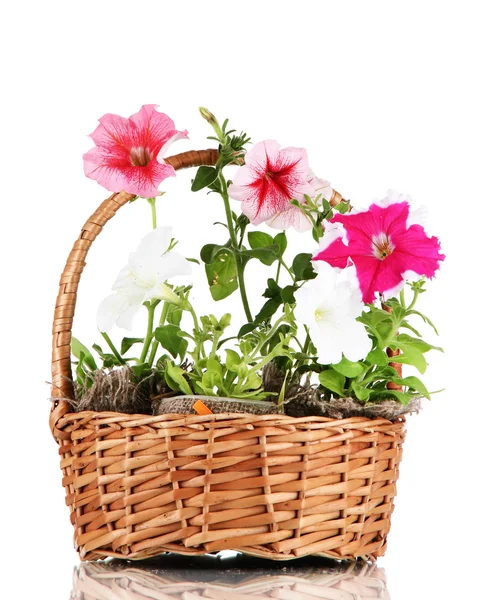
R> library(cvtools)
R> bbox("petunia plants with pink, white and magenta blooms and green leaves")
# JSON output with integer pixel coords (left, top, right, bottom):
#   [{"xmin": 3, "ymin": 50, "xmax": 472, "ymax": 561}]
[{"xmin": 72, "ymin": 105, "xmax": 444, "ymax": 406}]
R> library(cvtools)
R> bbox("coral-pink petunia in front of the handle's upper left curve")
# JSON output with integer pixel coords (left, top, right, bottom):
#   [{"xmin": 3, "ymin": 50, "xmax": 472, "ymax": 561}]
[{"xmin": 84, "ymin": 104, "xmax": 187, "ymax": 198}]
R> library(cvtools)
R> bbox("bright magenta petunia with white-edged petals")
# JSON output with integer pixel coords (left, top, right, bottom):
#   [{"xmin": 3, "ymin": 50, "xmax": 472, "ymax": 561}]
[{"xmin": 313, "ymin": 192, "xmax": 445, "ymax": 302}]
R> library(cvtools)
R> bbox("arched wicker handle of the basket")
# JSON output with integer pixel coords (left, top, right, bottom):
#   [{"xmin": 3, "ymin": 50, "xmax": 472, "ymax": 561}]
[{"xmin": 50, "ymin": 149, "xmax": 343, "ymax": 439}]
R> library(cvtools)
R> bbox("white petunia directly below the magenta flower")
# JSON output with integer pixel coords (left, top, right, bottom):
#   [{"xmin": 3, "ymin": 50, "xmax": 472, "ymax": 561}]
[{"xmin": 295, "ymin": 261, "xmax": 372, "ymax": 365}]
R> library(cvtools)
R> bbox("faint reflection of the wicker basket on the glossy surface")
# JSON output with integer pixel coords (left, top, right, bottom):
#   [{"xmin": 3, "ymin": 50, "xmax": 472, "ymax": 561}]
[{"xmin": 71, "ymin": 557, "xmax": 390, "ymax": 600}]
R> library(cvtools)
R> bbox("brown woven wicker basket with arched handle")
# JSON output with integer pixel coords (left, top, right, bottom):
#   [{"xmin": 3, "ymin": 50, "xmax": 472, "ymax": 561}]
[{"xmin": 50, "ymin": 150, "xmax": 405, "ymax": 560}]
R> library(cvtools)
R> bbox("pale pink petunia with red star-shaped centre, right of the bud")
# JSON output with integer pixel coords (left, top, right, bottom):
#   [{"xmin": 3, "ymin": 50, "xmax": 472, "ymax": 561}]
[{"xmin": 228, "ymin": 140, "xmax": 315, "ymax": 231}]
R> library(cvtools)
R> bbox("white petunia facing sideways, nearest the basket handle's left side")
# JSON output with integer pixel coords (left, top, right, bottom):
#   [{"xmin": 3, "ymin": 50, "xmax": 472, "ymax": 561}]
[{"xmin": 97, "ymin": 227, "xmax": 191, "ymax": 331}]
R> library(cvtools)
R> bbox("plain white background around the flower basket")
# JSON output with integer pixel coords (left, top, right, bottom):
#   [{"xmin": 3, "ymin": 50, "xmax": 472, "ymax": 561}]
[{"xmin": 0, "ymin": 0, "xmax": 482, "ymax": 600}]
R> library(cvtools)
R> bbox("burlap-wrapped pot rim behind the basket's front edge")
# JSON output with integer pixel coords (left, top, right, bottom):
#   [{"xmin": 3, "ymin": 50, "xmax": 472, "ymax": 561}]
[{"xmin": 152, "ymin": 396, "xmax": 282, "ymax": 415}]
